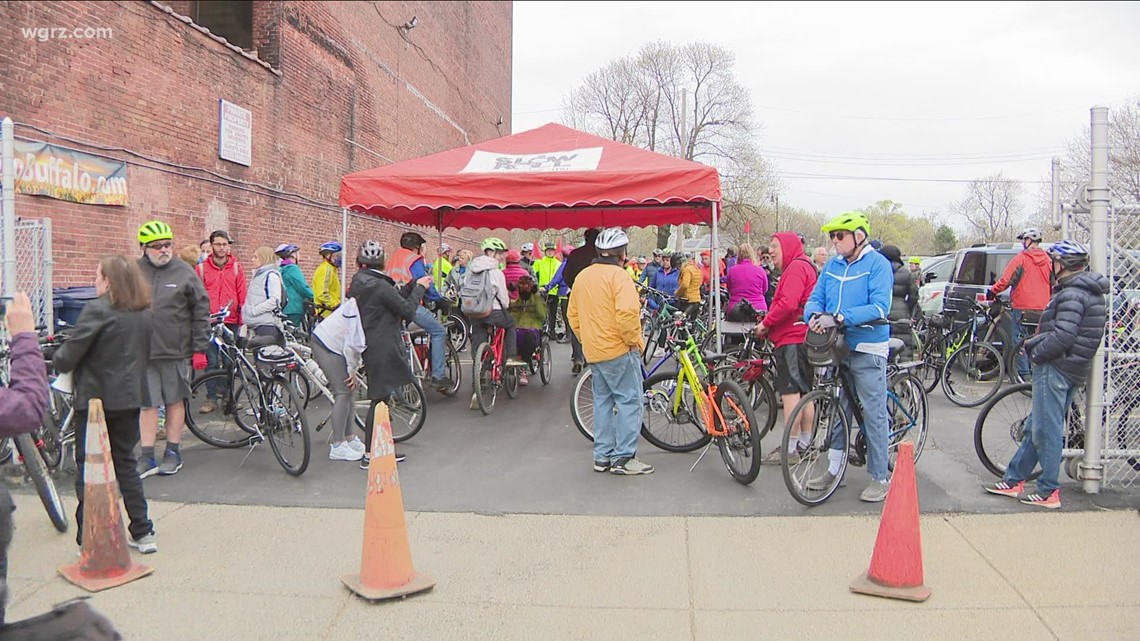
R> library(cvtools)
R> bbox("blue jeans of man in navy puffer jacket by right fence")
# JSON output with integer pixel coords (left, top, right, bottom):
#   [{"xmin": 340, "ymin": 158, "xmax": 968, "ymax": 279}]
[{"xmin": 1004, "ymin": 364, "xmax": 1077, "ymax": 496}]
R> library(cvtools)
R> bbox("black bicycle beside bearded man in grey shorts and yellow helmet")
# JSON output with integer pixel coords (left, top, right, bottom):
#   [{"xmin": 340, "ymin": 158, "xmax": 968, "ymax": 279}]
[{"xmin": 186, "ymin": 313, "xmax": 311, "ymax": 477}]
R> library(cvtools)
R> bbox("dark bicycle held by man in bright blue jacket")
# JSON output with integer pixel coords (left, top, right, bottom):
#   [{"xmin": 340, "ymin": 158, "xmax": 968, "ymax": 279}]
[{"xmin": 780, "ymin": 315, "xmax": 927, "ymax": 506}]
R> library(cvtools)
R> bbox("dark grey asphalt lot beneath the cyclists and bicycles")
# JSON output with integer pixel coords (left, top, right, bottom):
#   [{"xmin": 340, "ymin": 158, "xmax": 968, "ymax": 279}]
[{"xmin": 135, "ymin": 344, "xmax": 1140, "ymax": 516}]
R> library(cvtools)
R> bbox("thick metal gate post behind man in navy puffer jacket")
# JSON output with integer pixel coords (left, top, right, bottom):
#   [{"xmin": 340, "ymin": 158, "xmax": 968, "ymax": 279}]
[{"xmin": 1080, "ymin": 106, "xmax": 1112, "ymax": 494}]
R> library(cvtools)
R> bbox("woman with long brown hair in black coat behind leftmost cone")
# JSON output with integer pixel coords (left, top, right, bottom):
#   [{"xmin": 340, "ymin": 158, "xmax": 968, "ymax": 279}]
[{"xmin": 51, "ymin": 254, "xmax": 158, "ymax": 553}]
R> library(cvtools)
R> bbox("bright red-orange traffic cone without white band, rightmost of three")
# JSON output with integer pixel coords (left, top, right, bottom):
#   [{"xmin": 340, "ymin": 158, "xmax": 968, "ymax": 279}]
[{"xmin": 850, "ymin": 443, "xmax": 930, "ymax": 601}]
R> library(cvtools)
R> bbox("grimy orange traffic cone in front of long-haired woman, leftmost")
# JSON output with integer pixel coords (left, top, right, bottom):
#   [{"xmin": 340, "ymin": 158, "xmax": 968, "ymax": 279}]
[{"xmin": 59, "ymin": 398, "xmax": 154, "ymax": 592}]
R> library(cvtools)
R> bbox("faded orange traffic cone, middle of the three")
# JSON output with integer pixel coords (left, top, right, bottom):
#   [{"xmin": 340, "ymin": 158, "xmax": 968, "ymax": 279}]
[{"xmin": 341, "ymin": 403, "xmax": 435, "ymax": 601}]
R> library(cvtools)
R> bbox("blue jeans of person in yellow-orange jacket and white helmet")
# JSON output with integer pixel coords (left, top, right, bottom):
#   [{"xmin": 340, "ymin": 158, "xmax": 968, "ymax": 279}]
[{"xmin": 589, "ymin": 351, "xmax": 645, "ymax": 461}]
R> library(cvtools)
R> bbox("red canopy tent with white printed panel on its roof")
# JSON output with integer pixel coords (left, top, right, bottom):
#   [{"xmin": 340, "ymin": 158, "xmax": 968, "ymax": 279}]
[{"xmin": 340, "ymin": 123, "xmax": 720, "ymax": 339}]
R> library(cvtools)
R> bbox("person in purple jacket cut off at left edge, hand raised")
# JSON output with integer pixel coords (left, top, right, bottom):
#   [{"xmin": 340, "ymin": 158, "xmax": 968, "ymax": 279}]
[{"xmin": 0, "ymin": 292, "xmax": 48, "ymax": 625}]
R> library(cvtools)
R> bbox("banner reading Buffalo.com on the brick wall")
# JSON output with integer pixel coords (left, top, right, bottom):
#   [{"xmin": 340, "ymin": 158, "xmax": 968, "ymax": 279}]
[{"xmin": 14, "ymin": 140, "xmax": 127, "ymax": 205}]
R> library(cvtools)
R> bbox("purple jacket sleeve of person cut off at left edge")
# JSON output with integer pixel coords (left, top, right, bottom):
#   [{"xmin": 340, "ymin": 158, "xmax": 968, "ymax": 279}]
[{"xmin": 0, "ymin": 328, "xmax": 48, "ymax": 433}]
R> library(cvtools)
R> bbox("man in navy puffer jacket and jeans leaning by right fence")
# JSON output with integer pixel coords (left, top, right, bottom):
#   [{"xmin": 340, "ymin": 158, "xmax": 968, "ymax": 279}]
[{"xmin": 985, "ymin": 241, "xmax": 1108, "ymax": 510}]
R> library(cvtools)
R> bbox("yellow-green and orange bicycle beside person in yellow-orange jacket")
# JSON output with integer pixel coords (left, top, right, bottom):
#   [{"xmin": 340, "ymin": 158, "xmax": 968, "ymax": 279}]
[{"xmin": 643, "ymin": 311, "xmax": 762, "ymax": 485}]
